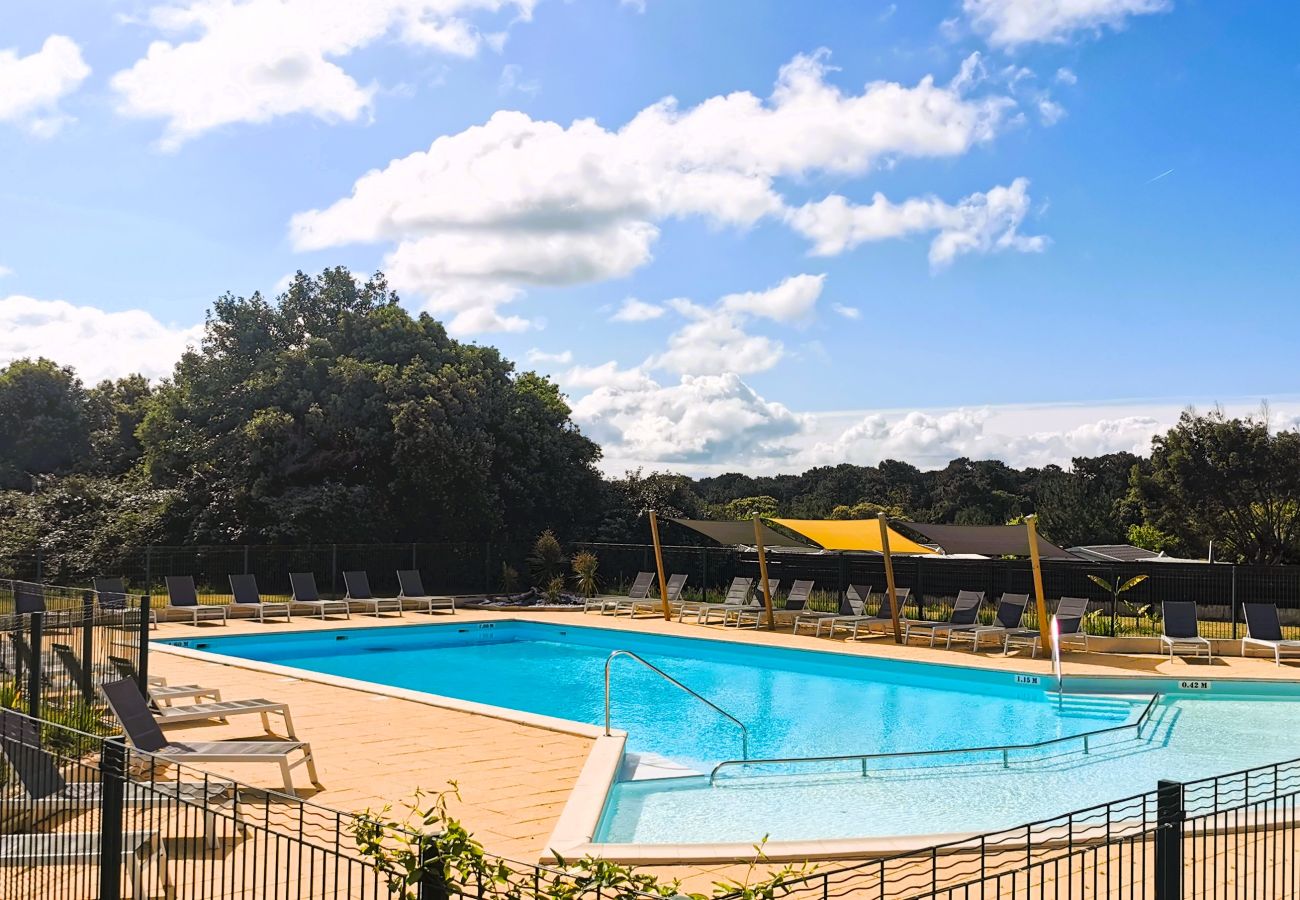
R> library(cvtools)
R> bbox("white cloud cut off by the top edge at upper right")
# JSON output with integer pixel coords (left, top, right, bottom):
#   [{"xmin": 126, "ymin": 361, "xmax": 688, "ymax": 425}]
[{"xmin": 962, "ymin": 0, "xmax": 1173, "ymax": 47}]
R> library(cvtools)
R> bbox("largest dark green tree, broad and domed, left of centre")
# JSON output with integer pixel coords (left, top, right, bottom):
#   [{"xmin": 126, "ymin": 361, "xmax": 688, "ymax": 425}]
[{"xmin": 138, "ymin": 268, "xmax": 599, "ymax": 542}]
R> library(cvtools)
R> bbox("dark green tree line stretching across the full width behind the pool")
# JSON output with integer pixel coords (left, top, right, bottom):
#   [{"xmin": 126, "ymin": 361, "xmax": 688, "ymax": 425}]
[{"xmin": 0, "ymin": 268, "xmax": 1300, "ymax": 575}]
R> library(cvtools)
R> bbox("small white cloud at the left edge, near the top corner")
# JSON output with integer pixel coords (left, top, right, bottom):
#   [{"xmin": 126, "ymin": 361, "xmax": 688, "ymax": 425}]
[{"xmin": 0, "ymin": 34, "xmax": 90, "ymax": 138}]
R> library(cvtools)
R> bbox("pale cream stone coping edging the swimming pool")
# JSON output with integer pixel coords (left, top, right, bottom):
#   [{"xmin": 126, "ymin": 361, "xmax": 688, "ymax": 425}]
[{"xmin": 151, "ymin": 614, "xmax": 1300, "ymax": 865}]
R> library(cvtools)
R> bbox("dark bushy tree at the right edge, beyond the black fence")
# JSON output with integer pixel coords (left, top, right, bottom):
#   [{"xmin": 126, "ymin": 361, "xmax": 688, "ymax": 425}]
[{"xmin": 1134, "ymin": 410, "xmax": 1300, "ymax": 563}]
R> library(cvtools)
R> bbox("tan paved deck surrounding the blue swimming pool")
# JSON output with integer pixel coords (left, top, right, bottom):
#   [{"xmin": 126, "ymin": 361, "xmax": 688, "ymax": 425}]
[{"xmin": 150, "ymin": 610, "xmax": 1300, "ymax": 890}]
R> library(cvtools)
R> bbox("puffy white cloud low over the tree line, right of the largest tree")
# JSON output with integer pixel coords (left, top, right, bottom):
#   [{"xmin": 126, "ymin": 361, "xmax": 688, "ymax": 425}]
[{"xmin": 573, "ymin": 373, "xmax": 802, "ymax": 468}]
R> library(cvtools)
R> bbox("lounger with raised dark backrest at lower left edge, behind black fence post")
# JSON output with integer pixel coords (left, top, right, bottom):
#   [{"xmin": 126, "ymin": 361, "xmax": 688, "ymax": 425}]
[{"xmin": 0, "ymin": 710, "xmax": 241, "ymax": 847}]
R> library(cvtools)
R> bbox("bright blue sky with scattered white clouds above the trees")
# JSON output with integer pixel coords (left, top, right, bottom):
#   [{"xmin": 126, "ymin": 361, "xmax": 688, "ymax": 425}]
[{"xmin": 0, "ymin": 0, "xmax": 1300, "ymax": 475}]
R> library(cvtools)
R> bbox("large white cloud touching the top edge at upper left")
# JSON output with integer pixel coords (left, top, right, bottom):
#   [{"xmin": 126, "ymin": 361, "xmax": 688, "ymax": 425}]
[{"xmin": 112, "ymin": 0, "xmax": 536, "ymax": 148}]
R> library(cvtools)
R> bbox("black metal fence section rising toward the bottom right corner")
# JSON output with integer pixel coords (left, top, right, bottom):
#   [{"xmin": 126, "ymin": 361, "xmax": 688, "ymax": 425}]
[{"xmin": 728, "ymin": 760, "xmax": 1300, "ymax": 900}]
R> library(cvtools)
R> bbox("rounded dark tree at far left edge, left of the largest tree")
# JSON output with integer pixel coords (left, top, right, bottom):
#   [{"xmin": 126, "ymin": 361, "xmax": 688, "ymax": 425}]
[{"xmin": 0, "ymin": 359, "xmax": 90, "ymax": 490}]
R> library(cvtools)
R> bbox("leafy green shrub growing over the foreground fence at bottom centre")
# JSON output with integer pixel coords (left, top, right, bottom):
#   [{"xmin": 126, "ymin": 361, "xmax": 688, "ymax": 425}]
[{"xmin": 348, "ymin": 782, "xmax": 813, "ymax": 900}]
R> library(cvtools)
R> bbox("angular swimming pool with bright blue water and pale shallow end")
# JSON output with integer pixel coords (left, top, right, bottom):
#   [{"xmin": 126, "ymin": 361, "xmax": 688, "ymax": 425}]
[{"xmin": 159, "ymin": 620, "xmax": 1300, "ymax": 844}]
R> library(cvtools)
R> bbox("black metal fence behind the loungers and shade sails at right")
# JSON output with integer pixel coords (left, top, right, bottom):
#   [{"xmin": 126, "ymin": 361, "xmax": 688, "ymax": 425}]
[{"xmin": 577, "ymin": 544, "xmax": 1300, "ymax": 639}]
